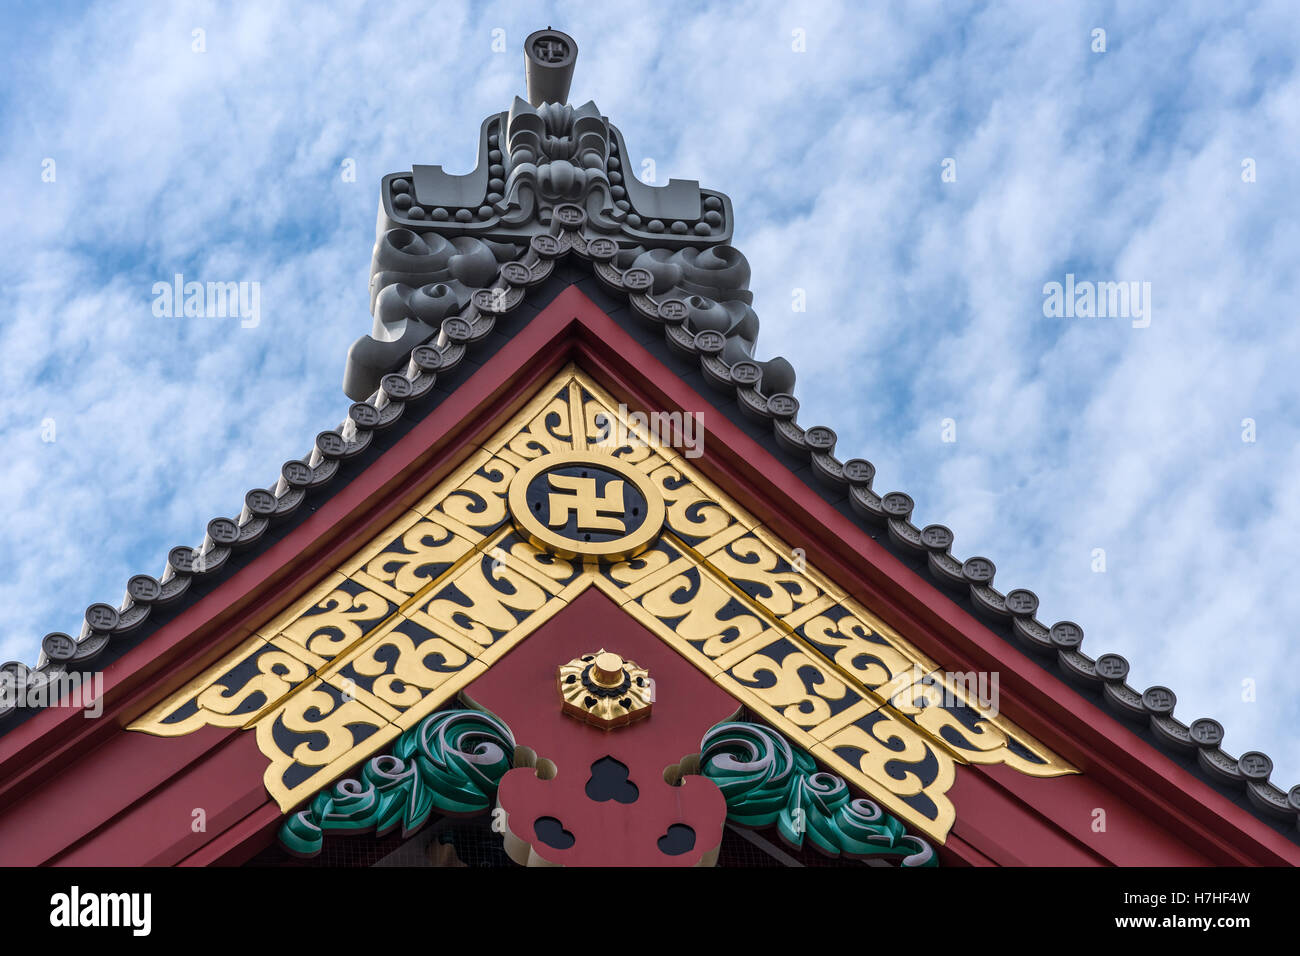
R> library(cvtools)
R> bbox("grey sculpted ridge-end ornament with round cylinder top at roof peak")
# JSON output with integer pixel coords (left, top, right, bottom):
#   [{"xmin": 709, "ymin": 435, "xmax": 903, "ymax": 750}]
[{"xmin": 343, "ymin": 27, "xmax": 794, "ymax": 402}]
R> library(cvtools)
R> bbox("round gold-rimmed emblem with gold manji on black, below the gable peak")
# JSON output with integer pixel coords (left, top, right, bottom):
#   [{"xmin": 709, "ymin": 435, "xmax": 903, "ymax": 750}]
[{"xmin": 507, "ymin": 451, "xmax": 664, "ymax": 561}]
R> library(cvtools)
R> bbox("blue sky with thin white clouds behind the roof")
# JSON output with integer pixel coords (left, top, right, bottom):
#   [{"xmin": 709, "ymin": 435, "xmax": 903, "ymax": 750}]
[{"xmin": 0, "ymin": 3, "xmax": 1300, "ymax": 787}]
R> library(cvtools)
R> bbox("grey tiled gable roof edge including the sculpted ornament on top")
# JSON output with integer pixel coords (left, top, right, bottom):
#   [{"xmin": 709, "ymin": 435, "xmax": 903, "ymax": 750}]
[{"xmin": 0, "ymin": 31, "xmax": 1300, "ymax": 842}]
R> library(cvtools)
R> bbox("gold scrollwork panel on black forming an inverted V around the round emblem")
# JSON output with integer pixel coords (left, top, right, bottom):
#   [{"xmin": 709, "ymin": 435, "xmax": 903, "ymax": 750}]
[{"xmin": 131, "ymin": 369, "xmax": 1074, "ymax": 842}]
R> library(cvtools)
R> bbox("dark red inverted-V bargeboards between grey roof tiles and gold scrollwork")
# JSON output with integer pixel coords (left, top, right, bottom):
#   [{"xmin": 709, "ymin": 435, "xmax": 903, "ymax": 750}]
[{"xmin": 0, "ymin": 273, "xmax": 1300, "ymax": 865}]
